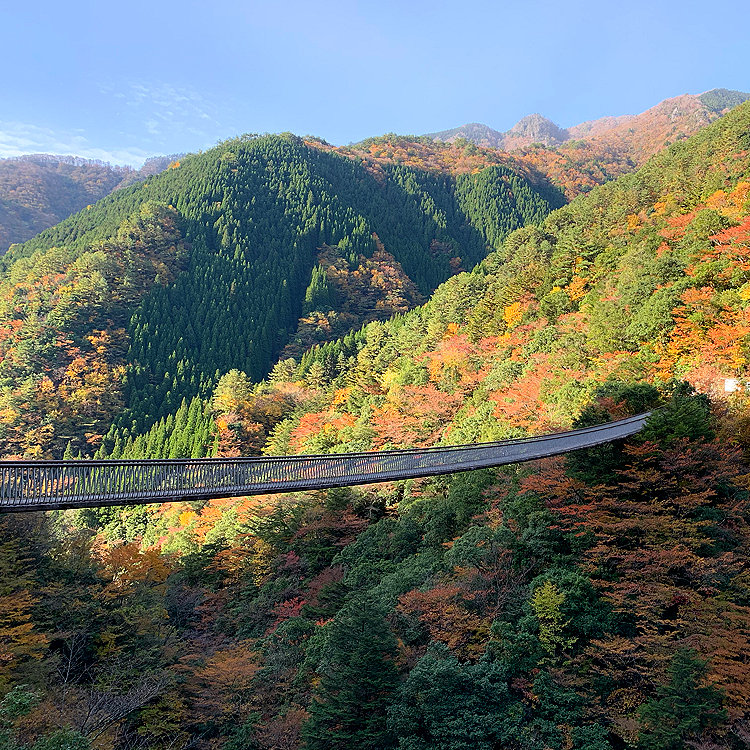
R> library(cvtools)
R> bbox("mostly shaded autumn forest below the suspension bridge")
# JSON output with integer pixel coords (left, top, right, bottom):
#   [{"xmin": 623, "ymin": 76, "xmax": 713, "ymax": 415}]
[{"xmin": 0, "ymin": 386, "xmax": 750, "ymax": 750}]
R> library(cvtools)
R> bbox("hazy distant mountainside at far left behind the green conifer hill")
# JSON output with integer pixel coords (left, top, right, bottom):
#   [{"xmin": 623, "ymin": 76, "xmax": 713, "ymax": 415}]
[{"xmin": 0, "ymin": 154, "xmax": 180, "ymax": 254}]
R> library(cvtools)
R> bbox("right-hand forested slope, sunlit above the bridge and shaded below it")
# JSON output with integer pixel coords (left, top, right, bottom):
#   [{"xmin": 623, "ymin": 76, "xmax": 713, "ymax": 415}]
[{"xmin": 0, "ymin": 104, "xmax": 750, "ymax": 750}]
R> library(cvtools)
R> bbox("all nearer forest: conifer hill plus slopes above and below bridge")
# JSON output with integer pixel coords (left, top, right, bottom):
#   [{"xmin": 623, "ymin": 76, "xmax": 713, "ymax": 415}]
[{"xmin": 0, "ymin": 95, "xmax": 750, "ymax": 750}]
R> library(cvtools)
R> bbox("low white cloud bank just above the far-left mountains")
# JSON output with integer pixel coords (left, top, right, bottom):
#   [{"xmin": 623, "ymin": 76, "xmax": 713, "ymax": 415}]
[{"xmin": 0, "ymin": 121, "xmax": 152, "ymax": 165}]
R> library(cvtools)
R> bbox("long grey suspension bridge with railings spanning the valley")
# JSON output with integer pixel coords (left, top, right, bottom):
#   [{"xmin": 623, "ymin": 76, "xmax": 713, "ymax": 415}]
[{"xmin": 0, "ymin": 412, "xmax": 651, "ymax": 512}]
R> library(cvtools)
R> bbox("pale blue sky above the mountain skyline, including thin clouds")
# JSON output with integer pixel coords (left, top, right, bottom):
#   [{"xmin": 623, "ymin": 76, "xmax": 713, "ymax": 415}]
[{"xmin": 0, "ymin": 0, "xmax": 750, "ymax": 164}]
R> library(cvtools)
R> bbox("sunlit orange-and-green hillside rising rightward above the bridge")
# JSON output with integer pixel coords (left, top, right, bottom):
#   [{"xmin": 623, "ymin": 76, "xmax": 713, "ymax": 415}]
[{"xmin": 262, "ymin": 98, "xmax": 750, "ymax": 451}]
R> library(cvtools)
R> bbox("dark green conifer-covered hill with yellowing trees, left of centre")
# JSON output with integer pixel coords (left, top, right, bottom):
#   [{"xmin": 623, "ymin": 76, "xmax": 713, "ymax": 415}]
[{"xmin": 0, "ymin": 135, "xmax": 562, "ymax": 457}]
